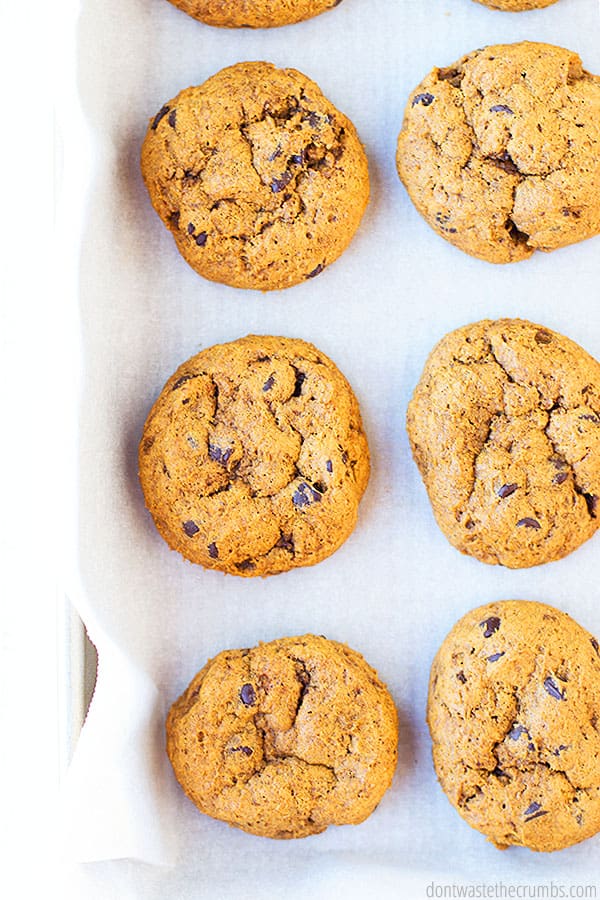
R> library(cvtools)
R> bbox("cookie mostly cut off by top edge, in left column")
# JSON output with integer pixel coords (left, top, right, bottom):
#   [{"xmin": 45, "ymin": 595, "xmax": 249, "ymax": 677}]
[{"xmin": 163, "ymin": 0, "xmax": 342, "ymax": 28}]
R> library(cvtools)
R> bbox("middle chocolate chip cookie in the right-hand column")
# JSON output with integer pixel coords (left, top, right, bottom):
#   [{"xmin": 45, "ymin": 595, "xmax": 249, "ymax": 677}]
[{"xmin": 407, "ymin": 319, "xmax": 600, "ymax": 568}]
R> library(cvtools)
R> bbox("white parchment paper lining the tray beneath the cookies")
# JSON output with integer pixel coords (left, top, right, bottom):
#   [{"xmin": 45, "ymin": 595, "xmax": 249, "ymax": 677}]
[{"xmin": 65, "ymin": 0, "xmax": 600, "ymax": 900}]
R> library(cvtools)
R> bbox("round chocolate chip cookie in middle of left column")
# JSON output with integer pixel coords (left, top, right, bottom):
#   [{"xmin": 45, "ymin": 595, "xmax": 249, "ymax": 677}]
[{"xmin": 139, "ymin": 335, "xmax": 369, "ymax": 576}]
